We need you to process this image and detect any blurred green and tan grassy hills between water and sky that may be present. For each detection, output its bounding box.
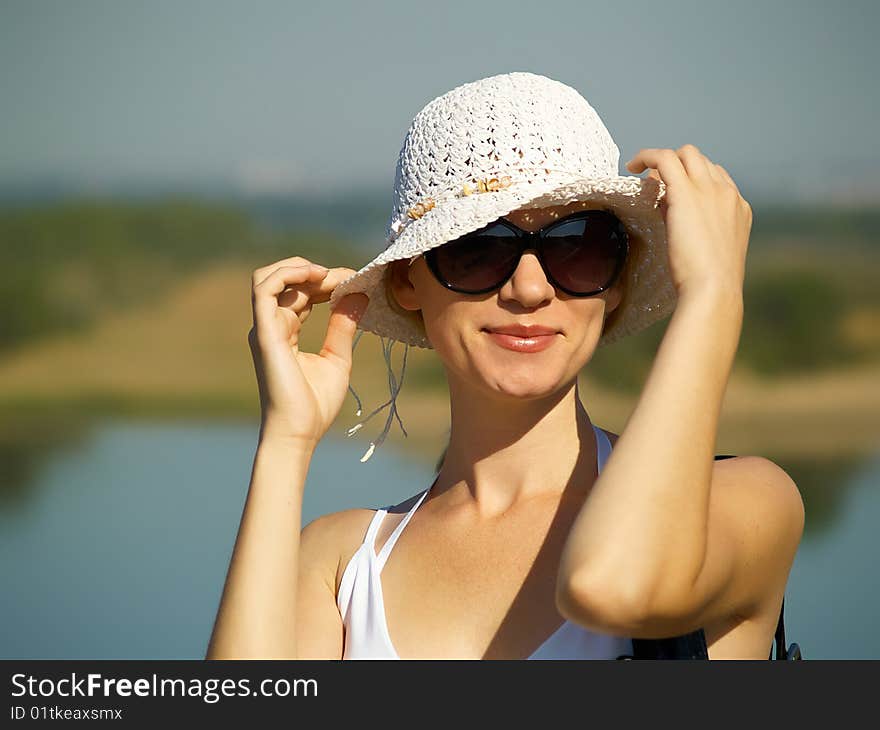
[0,193,880,460]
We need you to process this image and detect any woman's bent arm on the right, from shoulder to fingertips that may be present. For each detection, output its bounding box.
[556,145,804,638]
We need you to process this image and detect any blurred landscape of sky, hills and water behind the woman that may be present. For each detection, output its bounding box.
[0,0,880,658]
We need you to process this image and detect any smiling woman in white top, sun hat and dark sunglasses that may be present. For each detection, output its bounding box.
[208,73,804,659]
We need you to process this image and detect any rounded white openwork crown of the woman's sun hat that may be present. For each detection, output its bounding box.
[386,71,620,240]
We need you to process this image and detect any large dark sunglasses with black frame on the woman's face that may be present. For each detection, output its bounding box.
[410,210,629,297]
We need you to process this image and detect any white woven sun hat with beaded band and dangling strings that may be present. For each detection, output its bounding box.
[330,71,676,461]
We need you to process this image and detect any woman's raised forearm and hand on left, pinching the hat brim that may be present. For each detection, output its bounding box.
[206,257,367,659]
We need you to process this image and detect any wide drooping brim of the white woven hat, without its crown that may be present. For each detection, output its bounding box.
[330,176,676,349]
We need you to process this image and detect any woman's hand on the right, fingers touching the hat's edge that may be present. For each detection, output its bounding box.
[626,144,752,296]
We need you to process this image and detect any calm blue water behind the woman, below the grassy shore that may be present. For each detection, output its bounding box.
[0,421,880,659]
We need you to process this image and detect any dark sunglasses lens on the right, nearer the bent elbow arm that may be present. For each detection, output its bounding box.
[544,211,626,292]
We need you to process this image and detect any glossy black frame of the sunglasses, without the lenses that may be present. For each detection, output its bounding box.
[409,209,629,297]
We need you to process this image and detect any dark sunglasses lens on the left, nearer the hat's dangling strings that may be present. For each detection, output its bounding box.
[434,225,519,292]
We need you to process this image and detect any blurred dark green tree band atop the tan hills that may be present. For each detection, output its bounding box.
[0,199,880,390]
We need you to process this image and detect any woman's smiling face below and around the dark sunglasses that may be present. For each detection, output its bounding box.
[390,202,621,397]
